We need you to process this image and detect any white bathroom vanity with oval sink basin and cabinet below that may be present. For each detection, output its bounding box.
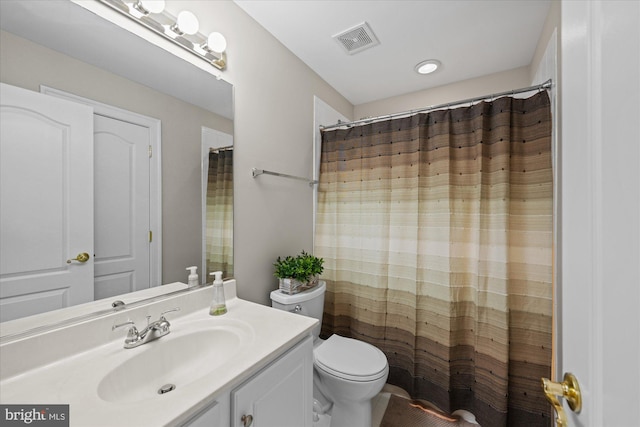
[0,280,317,427]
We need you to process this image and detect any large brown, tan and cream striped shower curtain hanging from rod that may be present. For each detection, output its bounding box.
[315,91,553,427]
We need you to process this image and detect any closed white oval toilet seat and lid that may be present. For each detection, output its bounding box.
[313,335,388,382]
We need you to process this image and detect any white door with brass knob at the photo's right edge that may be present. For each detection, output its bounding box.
[555,0,640,427]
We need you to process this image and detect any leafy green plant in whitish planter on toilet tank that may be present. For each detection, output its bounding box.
[273,251,324,295]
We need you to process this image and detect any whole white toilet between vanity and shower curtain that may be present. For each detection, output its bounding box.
[271,281,389,427]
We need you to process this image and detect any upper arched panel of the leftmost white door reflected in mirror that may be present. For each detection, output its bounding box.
[0,122,68,275]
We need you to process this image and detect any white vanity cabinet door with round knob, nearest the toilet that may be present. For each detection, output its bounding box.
[231,337,313,427]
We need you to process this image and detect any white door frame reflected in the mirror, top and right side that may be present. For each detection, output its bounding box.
[40,85,162,287]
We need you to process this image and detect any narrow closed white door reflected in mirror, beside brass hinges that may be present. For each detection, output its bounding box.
[94,114,151,299]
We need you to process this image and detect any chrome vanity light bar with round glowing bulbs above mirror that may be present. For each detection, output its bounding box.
[98,0,227,70]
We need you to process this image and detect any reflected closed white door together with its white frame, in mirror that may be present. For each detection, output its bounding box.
[40,86,162,299]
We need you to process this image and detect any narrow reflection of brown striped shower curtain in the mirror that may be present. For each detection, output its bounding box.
[205,148,233,280]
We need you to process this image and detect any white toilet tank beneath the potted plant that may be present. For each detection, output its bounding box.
[271,280,327,341]
